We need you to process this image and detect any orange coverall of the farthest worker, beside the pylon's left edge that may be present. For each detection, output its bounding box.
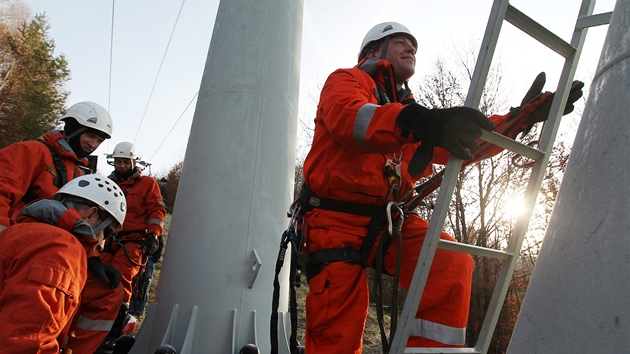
[101,168,166,303]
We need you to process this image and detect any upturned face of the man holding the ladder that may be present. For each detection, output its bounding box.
[368,36,416,82]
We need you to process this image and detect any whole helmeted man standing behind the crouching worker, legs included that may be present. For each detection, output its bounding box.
[0,101,129,353]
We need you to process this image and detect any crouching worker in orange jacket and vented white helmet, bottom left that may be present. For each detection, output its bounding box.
[0,175,127,353]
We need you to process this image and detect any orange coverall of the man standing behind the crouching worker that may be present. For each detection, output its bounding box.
[0,130,123,353]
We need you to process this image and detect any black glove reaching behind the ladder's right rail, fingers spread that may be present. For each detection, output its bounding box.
[516,72,584,127]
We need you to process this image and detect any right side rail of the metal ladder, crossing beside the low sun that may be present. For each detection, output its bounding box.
[475,0,595,353]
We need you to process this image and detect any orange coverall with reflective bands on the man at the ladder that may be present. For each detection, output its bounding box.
[304,60,507,353]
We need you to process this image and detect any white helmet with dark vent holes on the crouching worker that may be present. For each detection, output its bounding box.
[53,174,127,232]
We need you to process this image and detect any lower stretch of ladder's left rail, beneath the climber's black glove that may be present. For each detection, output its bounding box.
[389,156,463,354]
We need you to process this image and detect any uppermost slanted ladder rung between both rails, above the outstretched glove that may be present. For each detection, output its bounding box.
[505,5,575,58]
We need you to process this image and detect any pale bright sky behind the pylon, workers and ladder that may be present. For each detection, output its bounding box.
[24,0,615,175]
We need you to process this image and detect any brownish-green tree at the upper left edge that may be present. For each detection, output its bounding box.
[0,14,70,148]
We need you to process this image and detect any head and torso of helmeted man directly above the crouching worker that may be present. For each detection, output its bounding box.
[0,101,113,229]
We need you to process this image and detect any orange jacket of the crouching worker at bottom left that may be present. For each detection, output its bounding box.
[0,200,97,353]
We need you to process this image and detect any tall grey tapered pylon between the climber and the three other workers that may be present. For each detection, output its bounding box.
[131,0,304,354]
